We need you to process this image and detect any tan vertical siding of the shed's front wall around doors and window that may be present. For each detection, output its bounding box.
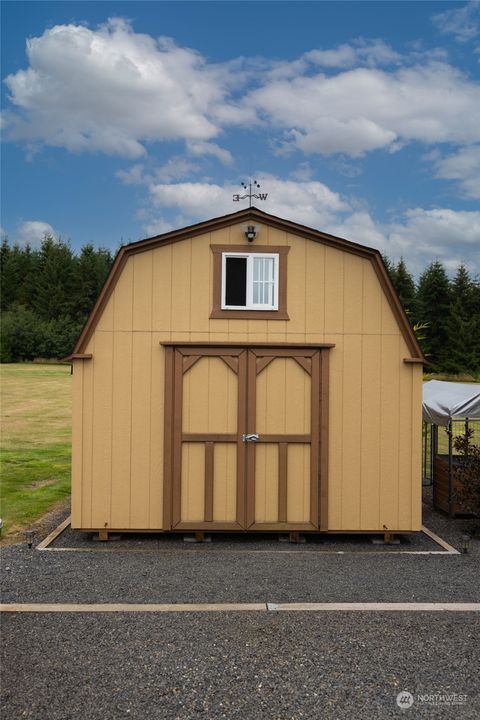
[72,225,421,530]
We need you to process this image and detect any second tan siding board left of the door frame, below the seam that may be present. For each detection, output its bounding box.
[130,332,151,528]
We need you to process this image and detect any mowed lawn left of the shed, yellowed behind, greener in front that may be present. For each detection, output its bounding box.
[0,363,71,535]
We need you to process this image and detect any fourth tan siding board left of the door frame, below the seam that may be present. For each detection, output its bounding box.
[92,332,113,528]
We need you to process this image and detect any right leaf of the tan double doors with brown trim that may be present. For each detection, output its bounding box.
[247,348,320,530]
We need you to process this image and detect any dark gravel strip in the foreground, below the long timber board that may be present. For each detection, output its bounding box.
[2,613,480,720]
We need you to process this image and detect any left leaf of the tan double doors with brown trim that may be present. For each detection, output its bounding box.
[171,348,247,530]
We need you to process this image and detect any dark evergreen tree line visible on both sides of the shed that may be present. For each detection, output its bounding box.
[0,236,480,373]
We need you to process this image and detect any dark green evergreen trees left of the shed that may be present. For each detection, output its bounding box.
[0,236,113,362]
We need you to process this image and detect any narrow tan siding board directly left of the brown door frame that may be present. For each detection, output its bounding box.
[149,338,165,529]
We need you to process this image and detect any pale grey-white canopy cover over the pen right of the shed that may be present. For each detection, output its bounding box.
[422,380,480,427]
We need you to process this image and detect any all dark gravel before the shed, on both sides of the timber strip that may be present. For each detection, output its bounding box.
[1,498,480,720]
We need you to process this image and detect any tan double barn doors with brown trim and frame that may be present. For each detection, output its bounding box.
[164,346,326,531]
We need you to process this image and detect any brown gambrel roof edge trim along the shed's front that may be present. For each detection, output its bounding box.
[65,207,425,361]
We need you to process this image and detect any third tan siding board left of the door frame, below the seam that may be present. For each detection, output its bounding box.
[112,332,133,529]
